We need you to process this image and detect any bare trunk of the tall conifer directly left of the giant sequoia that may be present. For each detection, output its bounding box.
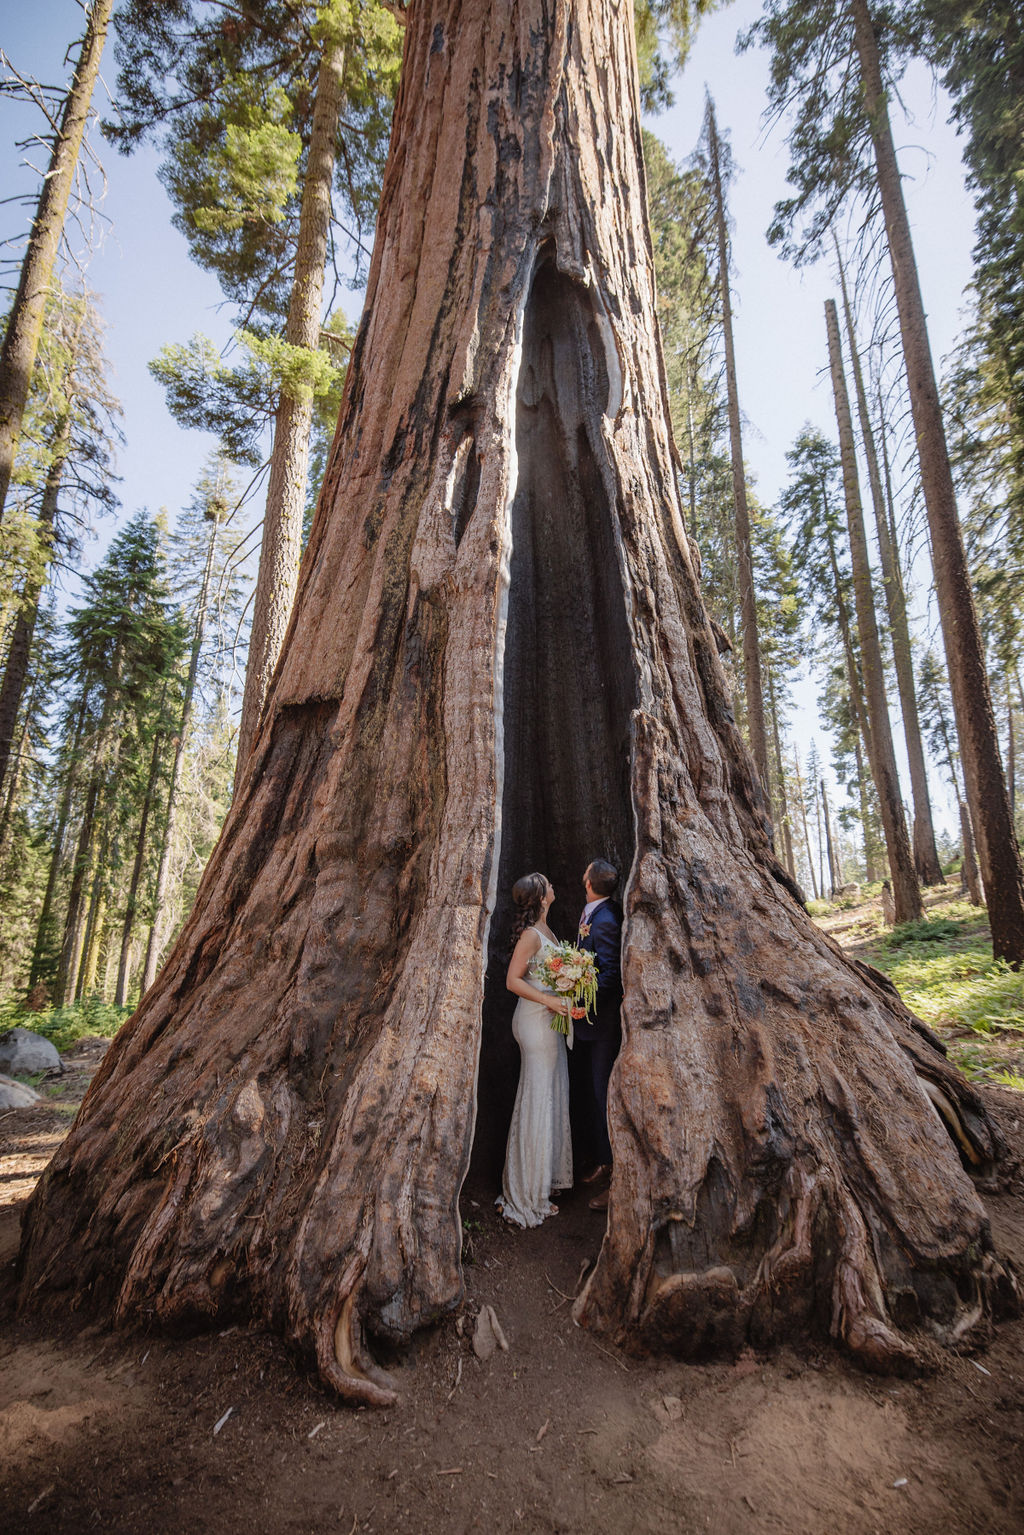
[234,37,345,779]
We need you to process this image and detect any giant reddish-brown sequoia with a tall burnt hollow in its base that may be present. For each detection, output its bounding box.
[21,0,1009,1401]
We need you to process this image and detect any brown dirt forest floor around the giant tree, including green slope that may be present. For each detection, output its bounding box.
[0,903,1024,1535]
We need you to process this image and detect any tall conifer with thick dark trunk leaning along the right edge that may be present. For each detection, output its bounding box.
[749,0,1024,964]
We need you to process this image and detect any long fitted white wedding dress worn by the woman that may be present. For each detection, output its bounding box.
[496,927,573,1226]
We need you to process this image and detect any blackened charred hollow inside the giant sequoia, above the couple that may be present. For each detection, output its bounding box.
[473,258,637,1180]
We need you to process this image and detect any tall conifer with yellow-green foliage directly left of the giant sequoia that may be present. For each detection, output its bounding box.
[111,0,401,772]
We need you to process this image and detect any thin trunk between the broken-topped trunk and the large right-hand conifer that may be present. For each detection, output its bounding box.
[835,241,944,884]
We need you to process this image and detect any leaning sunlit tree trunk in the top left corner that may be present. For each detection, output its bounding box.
[0,0,114,517]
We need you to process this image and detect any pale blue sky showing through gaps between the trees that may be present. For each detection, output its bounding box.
[0,0,973,841]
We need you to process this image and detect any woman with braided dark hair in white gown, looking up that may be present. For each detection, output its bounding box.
[496,873,573,1226]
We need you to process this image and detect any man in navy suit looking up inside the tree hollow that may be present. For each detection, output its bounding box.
[573,858,622,1210]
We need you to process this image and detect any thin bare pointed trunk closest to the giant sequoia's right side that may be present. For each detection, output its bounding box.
[708,100,769,794]
